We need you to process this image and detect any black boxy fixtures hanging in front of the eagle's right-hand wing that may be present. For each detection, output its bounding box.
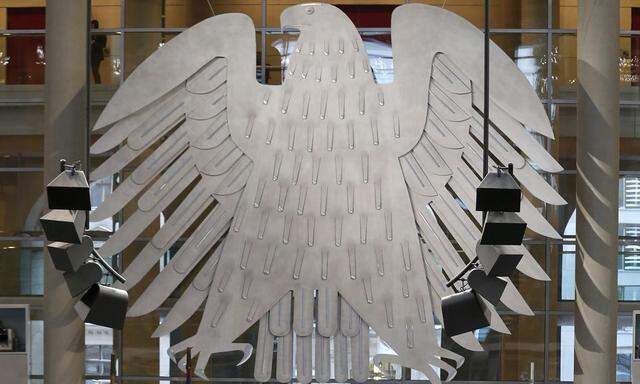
[442,164,527,336]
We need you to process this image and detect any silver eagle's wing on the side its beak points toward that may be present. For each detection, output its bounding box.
[91,14,270,340]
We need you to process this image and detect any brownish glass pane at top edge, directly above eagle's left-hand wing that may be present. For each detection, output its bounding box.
[125,0,262,28]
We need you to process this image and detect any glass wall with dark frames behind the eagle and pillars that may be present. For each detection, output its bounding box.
[0,0,640,384]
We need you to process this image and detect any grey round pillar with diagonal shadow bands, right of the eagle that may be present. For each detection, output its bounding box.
[574,0,620,384]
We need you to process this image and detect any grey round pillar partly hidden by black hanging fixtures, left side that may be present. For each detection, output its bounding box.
[44,0,88,384]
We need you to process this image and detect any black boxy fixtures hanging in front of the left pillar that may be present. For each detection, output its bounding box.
[40,160,129,329]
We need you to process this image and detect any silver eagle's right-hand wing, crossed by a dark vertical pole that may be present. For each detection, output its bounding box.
[389,4,566,349]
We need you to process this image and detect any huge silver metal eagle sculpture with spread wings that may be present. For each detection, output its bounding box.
[91,3,565,383]
